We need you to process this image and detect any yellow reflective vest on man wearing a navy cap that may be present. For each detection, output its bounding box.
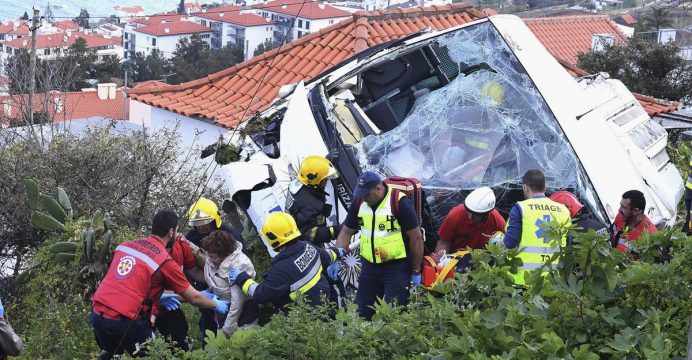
[358,186,406,263]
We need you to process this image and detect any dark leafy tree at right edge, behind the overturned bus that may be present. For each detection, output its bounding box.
[577,36,692,102]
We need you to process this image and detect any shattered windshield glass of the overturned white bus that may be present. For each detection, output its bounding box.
[346,22,594,236]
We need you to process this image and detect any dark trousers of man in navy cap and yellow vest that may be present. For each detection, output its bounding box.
[356,259,411,320]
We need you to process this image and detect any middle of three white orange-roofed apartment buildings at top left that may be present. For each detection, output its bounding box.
[193,10,274,60]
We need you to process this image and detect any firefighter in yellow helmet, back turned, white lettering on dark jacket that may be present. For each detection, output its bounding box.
[229,212,344,312]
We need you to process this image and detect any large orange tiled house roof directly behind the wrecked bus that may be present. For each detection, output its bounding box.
[128,4,483,127]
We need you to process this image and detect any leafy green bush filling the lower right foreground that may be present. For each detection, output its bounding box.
[137,226,692,360]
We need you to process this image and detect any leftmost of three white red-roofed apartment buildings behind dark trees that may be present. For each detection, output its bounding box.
[123,14,212,59]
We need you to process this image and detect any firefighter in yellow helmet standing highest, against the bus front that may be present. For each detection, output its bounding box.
[286,156,338,244]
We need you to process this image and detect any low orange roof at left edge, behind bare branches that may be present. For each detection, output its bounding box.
[0,89,129,121]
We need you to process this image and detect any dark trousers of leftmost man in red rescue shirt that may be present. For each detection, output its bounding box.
[89,311,154,360]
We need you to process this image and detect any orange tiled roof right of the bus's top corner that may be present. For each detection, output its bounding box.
[524,15,627,65]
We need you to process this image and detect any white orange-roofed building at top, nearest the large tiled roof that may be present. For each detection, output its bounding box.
[253,0,351,42]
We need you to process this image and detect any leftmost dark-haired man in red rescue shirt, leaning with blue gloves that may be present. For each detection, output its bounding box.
[89,210,228,359]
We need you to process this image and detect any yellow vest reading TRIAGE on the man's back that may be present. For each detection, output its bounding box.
[507,197,572,285]
